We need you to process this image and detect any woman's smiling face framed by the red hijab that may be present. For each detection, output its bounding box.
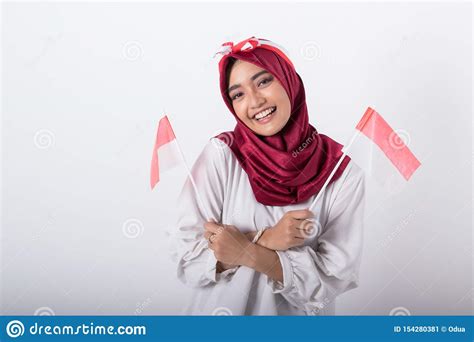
[227,60,291,136]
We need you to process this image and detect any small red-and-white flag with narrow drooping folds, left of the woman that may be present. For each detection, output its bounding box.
[150,115,183,190]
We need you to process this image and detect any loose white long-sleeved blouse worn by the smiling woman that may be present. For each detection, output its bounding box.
[172,138,365,315]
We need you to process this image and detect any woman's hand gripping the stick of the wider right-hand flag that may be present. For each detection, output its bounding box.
[257,209,316,251]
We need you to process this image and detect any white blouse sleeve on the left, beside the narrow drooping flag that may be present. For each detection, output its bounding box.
[173,139,237,287]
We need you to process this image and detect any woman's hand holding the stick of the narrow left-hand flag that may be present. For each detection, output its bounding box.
[204,222,252,265]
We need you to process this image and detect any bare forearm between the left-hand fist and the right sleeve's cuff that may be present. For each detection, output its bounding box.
[242,243,283,282]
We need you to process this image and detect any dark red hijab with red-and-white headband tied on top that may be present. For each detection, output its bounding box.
[217,37,350,206]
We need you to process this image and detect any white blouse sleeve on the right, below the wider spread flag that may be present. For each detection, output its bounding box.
[268,163,365,315]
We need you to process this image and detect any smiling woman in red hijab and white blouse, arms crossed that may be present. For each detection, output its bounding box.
[171,37,364,315]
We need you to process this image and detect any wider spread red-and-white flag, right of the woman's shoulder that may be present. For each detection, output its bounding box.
[343,107,421,186]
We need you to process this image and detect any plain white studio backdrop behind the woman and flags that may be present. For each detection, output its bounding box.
[1,2,473,315]
